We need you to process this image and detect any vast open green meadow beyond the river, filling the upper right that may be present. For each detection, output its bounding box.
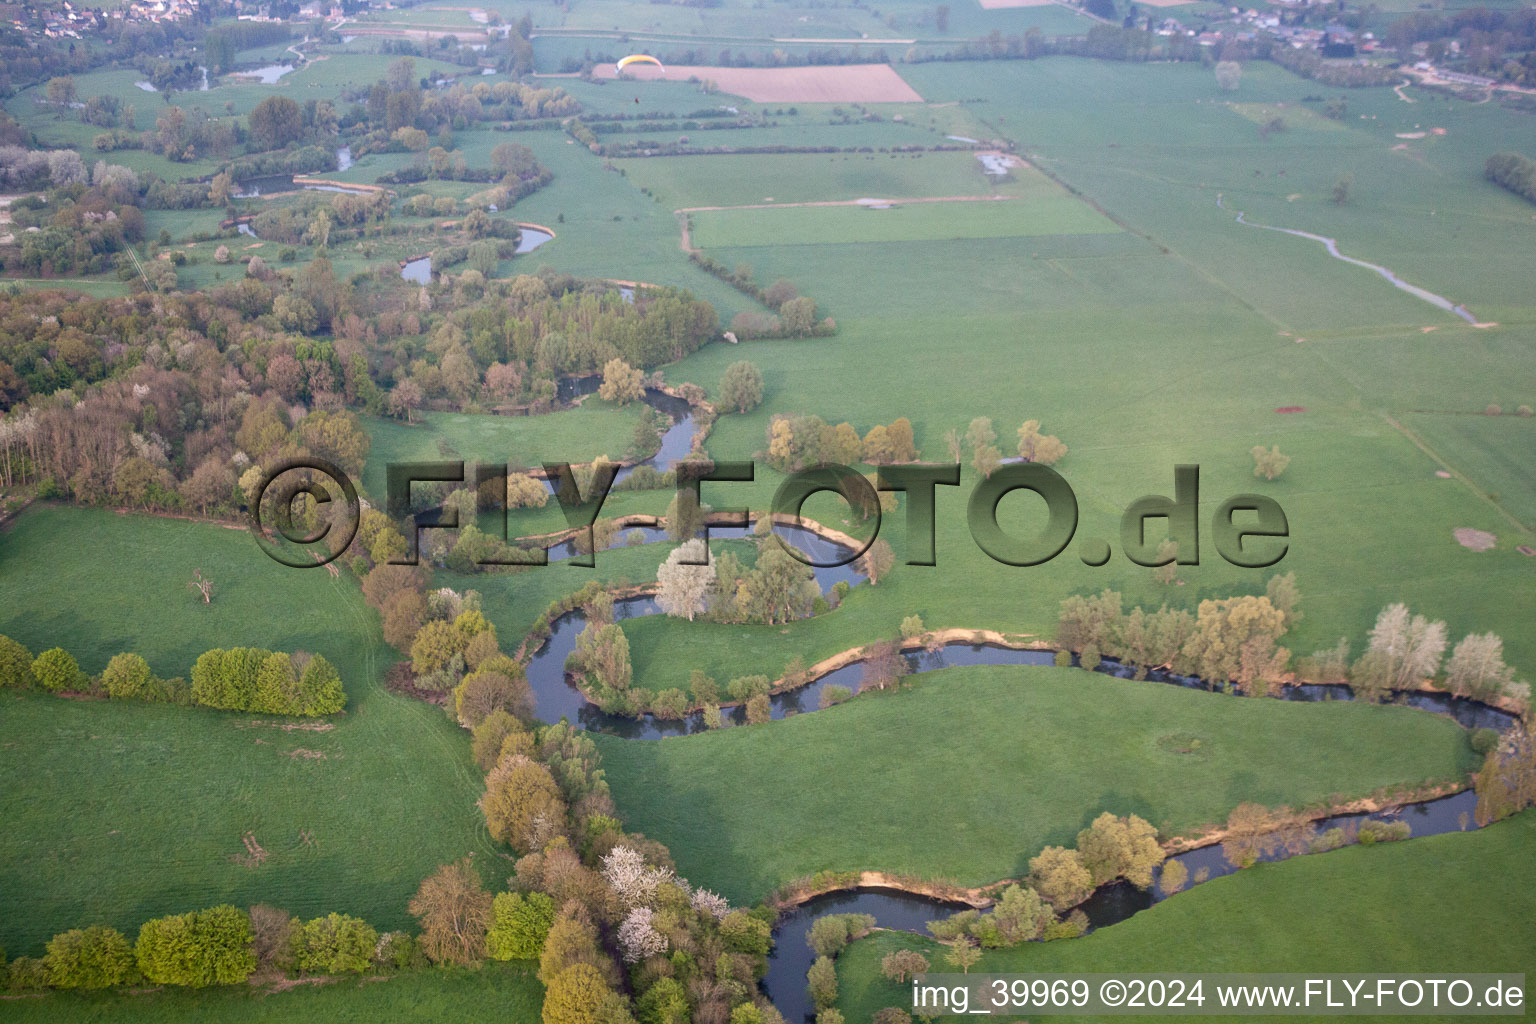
[577,60,1536,685]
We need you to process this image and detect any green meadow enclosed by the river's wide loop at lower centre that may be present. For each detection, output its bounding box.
[598,668,1475,902]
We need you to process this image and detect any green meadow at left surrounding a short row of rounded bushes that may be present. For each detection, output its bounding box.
[0,508,493,956]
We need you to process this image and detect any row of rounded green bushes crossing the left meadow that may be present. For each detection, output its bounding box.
[0,636,347,715]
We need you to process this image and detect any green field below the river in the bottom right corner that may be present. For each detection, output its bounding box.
[837,812,1536,1021]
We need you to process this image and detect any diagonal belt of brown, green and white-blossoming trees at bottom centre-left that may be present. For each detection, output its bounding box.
[337,517,782,1024]
